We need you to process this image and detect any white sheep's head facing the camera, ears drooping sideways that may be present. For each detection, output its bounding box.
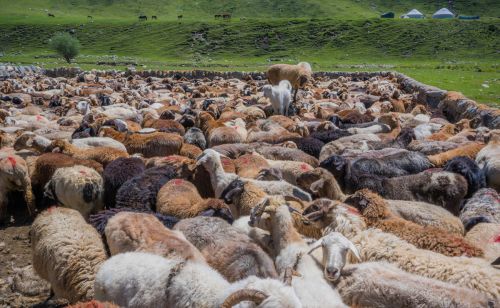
[309,232,361,282]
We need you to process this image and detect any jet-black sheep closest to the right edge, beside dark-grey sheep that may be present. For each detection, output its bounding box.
[444,156,486,198]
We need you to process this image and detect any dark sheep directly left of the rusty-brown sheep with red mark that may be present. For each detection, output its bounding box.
[116,166,179,211]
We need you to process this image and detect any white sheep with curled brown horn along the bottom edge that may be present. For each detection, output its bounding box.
[95,252,302,308]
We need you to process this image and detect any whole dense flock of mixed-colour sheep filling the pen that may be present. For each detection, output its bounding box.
[0,63,500,307]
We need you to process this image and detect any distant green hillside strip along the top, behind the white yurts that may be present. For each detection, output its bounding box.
[0,0,500,22]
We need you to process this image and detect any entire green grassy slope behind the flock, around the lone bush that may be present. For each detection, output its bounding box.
[0,0,500,103]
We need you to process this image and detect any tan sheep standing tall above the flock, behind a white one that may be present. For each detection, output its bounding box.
[267,62,312,103]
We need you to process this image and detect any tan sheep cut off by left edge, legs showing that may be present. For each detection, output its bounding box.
[0,151,35,221]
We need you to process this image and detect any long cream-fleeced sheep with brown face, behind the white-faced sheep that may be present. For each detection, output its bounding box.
[303,203,500,301]
